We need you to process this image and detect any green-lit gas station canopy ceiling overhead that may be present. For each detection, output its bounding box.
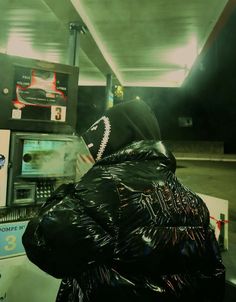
[0,0,232,87]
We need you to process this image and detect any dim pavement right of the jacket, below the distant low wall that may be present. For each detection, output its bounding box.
[175,158,236,286]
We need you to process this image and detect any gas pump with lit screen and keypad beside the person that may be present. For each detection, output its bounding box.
[0,54,93,302]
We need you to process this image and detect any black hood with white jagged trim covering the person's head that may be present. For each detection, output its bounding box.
[82,100,161,161]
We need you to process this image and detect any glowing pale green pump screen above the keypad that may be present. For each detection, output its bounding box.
[21,139,74,177]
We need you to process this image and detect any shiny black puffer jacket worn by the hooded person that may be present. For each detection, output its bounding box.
[23,141,225,302]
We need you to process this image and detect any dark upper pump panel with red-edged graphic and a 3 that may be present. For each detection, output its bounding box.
[12,66,69,122]
